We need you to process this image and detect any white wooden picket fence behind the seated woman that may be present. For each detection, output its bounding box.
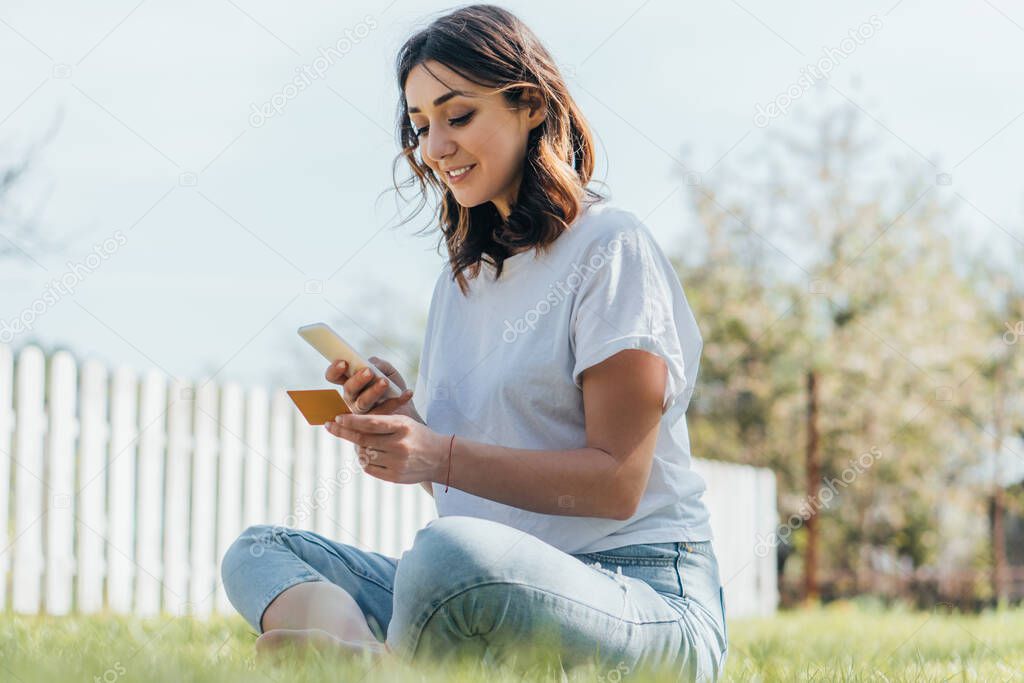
[0,345,777,616]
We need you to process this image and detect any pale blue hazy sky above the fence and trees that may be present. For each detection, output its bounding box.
[0,0,1024,395]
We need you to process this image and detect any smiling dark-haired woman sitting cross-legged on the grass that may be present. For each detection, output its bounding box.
[222,5,727,680]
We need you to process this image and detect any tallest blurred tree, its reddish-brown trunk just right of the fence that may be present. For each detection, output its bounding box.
[677,100,987,598]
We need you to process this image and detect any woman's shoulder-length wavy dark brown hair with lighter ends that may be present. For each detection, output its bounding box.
[393,4,605,295]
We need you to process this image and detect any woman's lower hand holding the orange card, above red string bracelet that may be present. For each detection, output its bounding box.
[324,414,449,483]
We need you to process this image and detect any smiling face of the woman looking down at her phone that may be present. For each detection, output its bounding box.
[406,59,545,217]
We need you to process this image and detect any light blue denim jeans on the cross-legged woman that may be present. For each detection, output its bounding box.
[221,516,728,681]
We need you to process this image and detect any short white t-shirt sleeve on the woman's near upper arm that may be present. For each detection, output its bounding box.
[570,214,702,419]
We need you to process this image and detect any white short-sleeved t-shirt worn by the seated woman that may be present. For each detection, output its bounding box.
[414,202,712,553]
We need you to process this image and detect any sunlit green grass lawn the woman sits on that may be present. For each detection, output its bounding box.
[0,603,1024,683]
